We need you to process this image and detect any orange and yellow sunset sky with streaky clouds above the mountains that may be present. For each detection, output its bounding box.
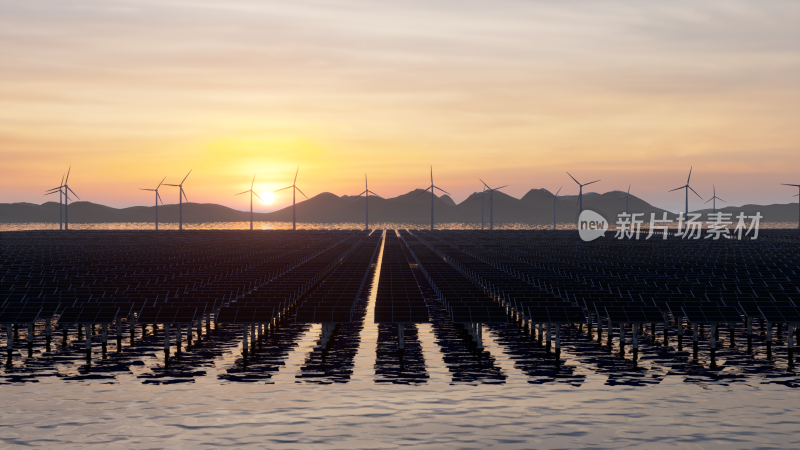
[0,0,800,211]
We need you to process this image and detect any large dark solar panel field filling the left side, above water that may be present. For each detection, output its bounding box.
[0,231,364,354]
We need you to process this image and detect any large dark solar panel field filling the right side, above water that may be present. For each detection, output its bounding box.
[415,230,800,354]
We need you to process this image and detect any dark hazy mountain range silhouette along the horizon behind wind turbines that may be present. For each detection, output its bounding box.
[0,189,798,224]
